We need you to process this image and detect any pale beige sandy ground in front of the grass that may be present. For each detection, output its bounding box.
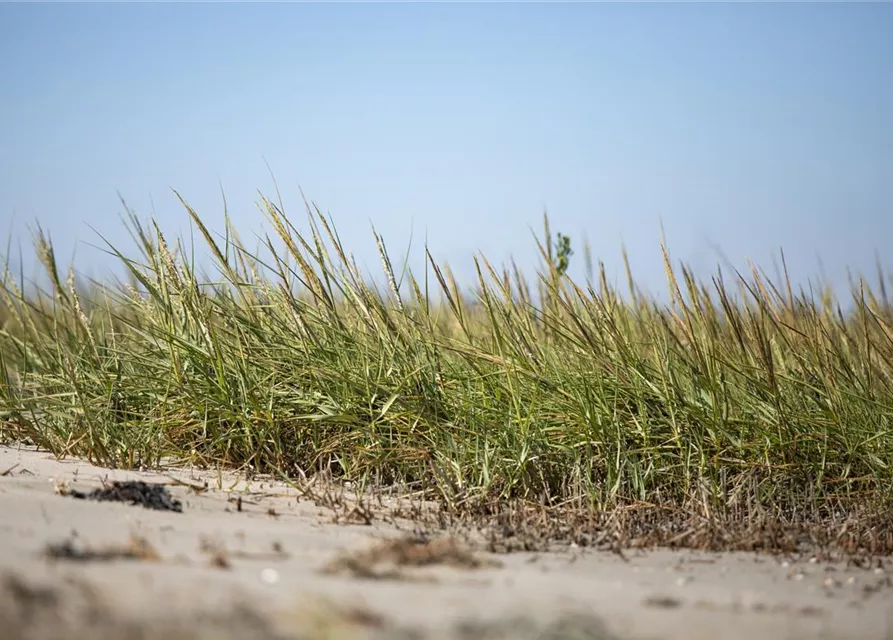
[0,447,893,640]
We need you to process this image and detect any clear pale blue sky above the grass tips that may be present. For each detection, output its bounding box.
[0,2,893,298]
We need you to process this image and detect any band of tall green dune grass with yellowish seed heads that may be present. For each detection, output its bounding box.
[0,192,893,532]
